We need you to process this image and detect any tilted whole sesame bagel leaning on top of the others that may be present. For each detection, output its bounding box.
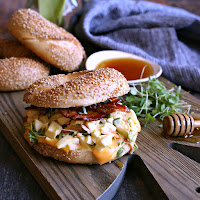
[8,9,85,72]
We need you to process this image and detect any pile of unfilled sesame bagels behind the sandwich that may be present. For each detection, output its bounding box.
[0,9,85,91]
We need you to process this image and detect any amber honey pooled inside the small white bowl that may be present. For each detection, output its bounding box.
[97,58,154,81]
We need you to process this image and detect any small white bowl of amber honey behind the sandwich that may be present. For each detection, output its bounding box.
[85,50,162,84]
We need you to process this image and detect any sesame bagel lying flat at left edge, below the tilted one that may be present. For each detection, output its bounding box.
[0,57,49,91]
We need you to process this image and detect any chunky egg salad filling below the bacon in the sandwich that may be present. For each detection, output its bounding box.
[24,105,141,164]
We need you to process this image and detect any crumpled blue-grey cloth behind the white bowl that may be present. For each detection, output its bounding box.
[71,0,200,92]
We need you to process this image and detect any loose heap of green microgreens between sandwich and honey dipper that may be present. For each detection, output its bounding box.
[121,77,191,126]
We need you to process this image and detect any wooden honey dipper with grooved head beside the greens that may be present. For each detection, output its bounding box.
[163,114,200,136]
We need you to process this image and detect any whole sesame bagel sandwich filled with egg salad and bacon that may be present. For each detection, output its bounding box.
[23,68,141,165]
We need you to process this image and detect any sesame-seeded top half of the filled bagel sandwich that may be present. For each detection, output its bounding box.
[24,68,129,108]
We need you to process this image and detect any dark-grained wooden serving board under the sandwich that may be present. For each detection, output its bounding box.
[0,78,200,200]
